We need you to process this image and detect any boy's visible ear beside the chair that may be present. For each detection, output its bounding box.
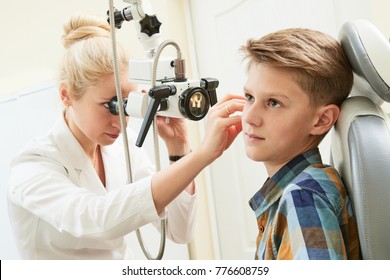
[311,104,340,135]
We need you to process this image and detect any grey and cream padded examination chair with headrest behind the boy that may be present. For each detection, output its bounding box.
[330,20,390,260]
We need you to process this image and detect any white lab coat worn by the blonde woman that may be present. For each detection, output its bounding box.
[8,115,196,259]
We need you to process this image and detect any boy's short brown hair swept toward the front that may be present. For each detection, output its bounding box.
[241,28,353,106]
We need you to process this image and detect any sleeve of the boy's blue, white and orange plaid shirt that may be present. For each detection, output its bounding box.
[273,189,347,260]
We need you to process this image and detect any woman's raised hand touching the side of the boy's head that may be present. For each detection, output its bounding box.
[199,94,245,161]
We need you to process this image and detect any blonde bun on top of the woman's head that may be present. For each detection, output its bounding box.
[62,14,110,48]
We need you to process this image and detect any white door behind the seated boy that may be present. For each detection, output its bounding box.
[189,0,370,259]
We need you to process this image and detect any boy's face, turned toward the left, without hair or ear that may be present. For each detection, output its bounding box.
[242,63,317,176]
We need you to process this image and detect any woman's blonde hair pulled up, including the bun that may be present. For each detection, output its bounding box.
[60,14,128,99]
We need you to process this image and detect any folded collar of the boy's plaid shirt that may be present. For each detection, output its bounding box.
[249,148,322,217]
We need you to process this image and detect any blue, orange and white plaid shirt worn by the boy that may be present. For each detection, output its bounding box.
[249,148,360,260]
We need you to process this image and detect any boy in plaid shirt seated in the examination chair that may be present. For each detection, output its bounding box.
[241,28,360,260]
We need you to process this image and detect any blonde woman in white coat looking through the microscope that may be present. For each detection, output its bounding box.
[8,12,243,259]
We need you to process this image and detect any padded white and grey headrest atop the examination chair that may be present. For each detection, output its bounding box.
[339,20,390,102]
